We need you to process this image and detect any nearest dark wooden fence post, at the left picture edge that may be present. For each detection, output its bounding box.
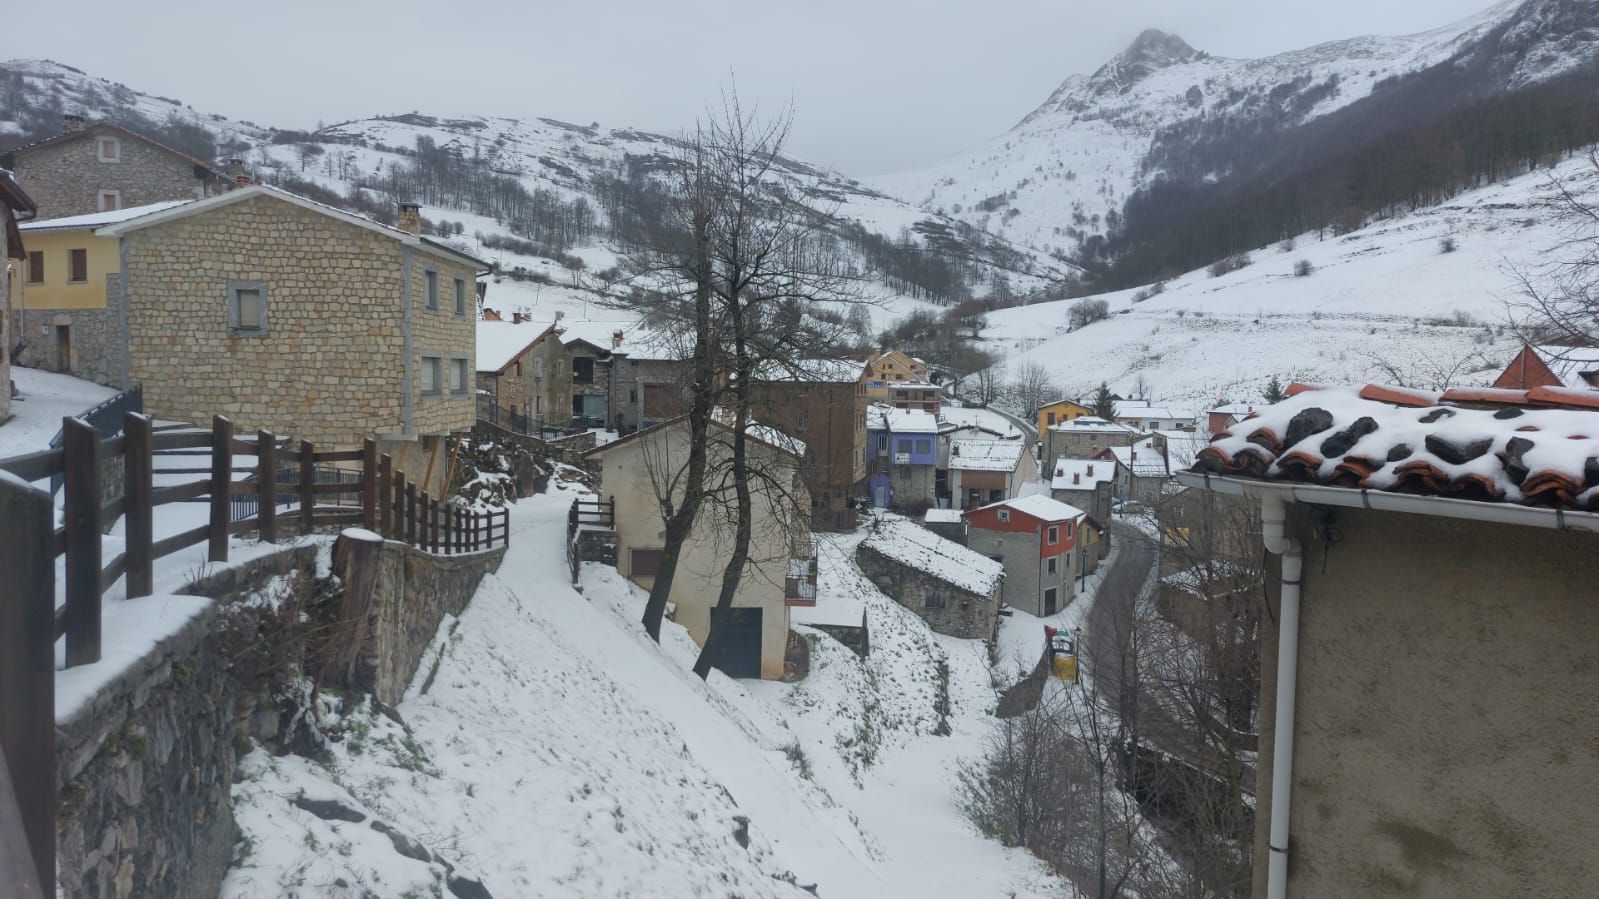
[0,478,55,896]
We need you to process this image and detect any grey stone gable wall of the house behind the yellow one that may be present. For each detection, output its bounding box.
[16,128,212,219]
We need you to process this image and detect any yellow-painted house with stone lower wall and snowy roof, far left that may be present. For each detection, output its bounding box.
[11,200,184,380]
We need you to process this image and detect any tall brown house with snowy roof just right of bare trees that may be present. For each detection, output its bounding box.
[750,353,867,531]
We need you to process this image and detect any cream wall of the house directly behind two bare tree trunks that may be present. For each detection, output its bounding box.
[590,422,807,678]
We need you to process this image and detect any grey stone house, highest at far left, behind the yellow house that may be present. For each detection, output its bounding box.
[0,115,235,219]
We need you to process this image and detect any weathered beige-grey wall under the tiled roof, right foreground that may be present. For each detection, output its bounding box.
[1255,505,1599,897]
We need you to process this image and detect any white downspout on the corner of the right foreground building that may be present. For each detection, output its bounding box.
[1260,493,1305,899]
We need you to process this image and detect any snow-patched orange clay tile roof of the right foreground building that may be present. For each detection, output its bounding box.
[1194,384,1599,510]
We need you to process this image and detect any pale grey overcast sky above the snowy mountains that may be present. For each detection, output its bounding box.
[12,0,1490,176]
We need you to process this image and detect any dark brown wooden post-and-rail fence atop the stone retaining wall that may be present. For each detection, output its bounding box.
[0,413,510,885]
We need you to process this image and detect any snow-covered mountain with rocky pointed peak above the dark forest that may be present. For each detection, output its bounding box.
[870,0,1599,253]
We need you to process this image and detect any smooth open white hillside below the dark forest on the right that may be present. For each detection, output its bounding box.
[983,152,1588,411]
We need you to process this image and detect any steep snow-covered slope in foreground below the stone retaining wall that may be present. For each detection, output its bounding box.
[222,481,1063,897]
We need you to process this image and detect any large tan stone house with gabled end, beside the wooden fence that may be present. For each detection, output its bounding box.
[98,186,488,493]
